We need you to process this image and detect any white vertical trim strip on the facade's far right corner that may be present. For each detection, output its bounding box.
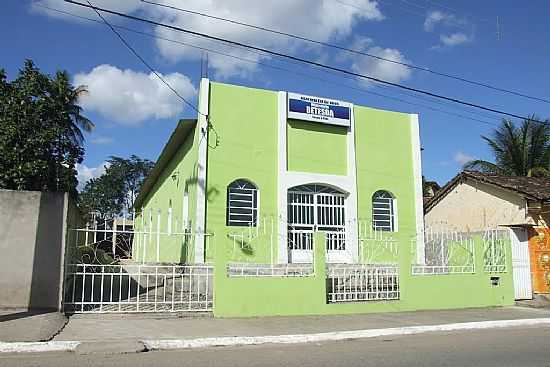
[410,114,426,265]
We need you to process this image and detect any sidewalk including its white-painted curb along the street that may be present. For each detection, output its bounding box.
[0,307,550,354]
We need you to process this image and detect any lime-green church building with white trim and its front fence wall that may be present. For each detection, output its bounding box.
[110,79,514,317]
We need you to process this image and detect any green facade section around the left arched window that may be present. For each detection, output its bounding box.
[206,83,278,263]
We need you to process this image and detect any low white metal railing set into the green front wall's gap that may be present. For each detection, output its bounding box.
[327,265,400,303]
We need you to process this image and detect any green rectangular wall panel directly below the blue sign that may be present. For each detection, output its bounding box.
[287,120,348,175]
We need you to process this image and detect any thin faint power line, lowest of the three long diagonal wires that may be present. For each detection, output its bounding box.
[36,4,498,126]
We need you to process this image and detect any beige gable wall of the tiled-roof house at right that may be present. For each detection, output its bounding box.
[425,181,533,231]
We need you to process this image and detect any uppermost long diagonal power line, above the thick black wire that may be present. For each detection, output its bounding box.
[141,0,550,103]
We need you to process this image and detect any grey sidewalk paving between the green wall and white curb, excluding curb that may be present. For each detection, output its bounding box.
[54,307,550,341]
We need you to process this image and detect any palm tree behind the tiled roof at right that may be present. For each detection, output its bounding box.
[464,115,550,177]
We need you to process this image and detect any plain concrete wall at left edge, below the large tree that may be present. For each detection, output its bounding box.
[0,190,73,309]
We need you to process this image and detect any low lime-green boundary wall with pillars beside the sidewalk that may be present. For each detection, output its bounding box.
[214,233,514,317]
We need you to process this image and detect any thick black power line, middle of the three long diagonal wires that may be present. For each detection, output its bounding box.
[64,0,547,125]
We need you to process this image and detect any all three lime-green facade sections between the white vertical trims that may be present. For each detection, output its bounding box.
[206,83,416,263]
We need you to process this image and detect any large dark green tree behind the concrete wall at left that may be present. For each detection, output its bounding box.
[0,60,94,194]
